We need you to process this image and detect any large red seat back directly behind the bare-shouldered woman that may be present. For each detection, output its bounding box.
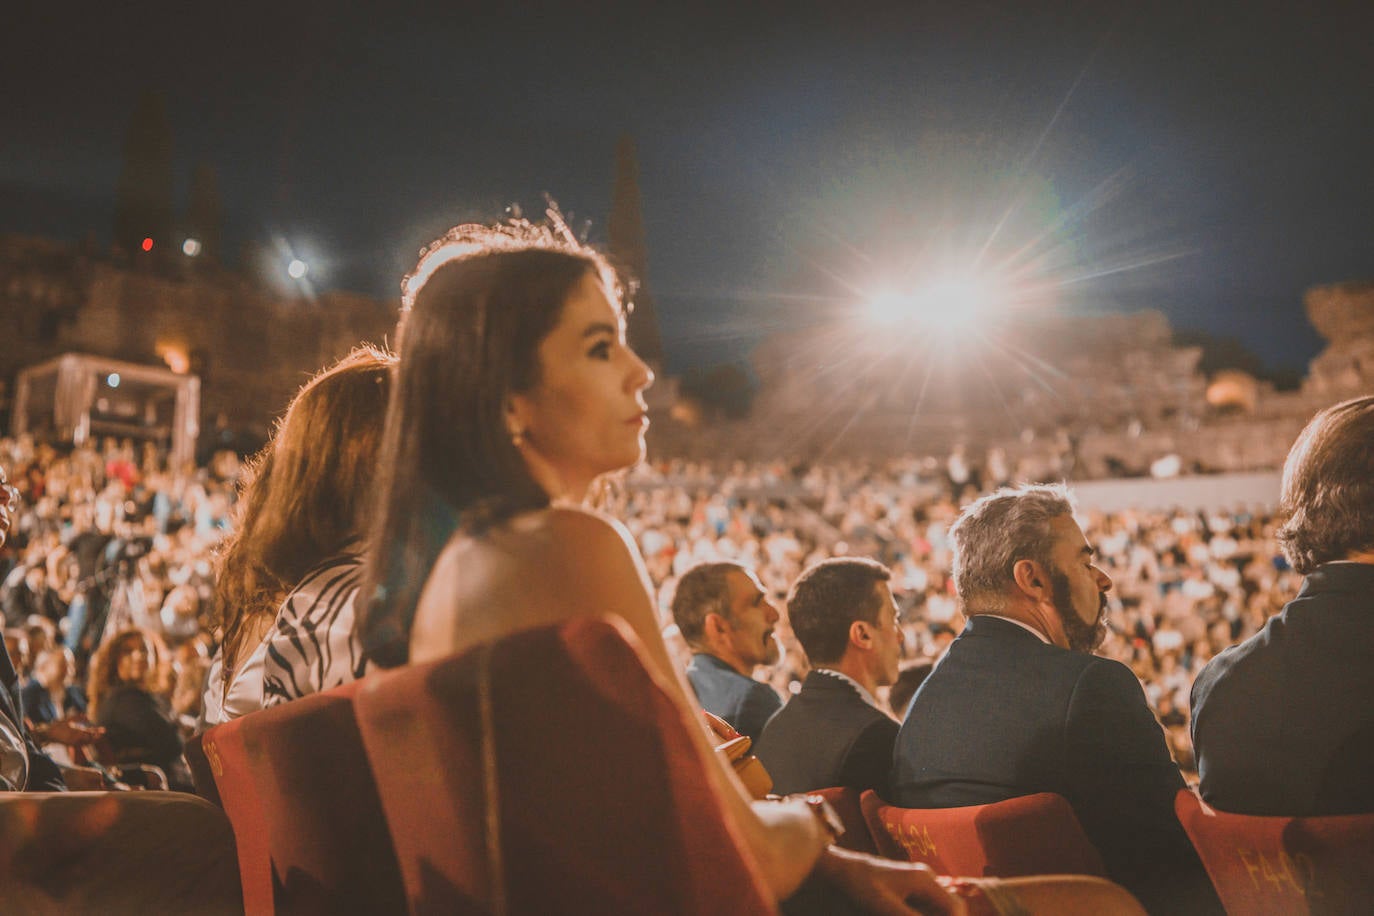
[357,619,775,916]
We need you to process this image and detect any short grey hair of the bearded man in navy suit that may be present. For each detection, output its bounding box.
[949,483,1073,614]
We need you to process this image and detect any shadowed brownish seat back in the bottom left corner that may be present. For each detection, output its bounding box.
[0,792,243,916]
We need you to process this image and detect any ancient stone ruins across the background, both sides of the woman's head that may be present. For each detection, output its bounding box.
[0,236,1374,475]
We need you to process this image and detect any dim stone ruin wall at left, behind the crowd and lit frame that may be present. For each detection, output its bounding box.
[0,236,397,441]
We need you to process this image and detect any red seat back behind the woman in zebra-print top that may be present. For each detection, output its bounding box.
[203,683,405,916]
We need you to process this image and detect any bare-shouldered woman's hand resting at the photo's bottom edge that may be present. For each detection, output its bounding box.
[816,846,967,916]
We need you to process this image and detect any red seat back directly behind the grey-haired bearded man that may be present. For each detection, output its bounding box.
[861,791,1106,878]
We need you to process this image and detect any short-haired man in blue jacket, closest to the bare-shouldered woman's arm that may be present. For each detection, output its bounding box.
[672,563,782,740]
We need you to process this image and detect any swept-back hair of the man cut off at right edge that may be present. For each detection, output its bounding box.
[1278,397,1374,575]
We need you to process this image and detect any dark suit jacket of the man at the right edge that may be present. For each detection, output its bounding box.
[1193,563,1374,816]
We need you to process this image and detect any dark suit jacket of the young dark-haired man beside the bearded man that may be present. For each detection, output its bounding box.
[754,672,897,795]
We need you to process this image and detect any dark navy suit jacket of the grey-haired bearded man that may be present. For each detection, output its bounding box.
[889,615,1220,913]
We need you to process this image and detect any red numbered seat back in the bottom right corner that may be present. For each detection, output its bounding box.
[1173,788,1374,916]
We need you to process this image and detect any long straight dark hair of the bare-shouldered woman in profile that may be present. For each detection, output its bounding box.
[359,221,628,666]
